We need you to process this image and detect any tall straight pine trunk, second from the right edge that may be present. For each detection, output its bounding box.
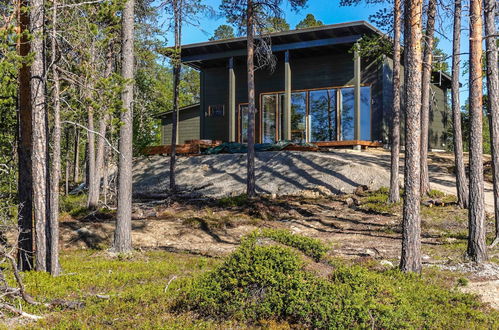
[468,0,488,262]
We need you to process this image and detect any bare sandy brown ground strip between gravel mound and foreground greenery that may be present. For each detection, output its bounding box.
[54,189,499,314]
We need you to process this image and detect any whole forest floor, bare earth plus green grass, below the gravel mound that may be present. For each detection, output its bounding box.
[0,152,499,329]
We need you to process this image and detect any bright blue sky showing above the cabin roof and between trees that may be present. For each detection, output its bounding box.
[162,0,468,102]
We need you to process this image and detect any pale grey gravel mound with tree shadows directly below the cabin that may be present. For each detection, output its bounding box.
[133,151,389,197]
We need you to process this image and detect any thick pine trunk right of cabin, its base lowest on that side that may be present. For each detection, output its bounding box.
[400,0,422,273]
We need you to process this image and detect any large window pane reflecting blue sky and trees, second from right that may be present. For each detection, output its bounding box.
[309,89,336,142]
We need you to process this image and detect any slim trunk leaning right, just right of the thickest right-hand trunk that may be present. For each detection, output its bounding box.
[420,0,437,196]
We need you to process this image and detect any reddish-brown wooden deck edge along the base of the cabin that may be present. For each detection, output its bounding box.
[142,140,383,156]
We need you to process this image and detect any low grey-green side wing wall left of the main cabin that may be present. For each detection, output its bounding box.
[161,107,200,145]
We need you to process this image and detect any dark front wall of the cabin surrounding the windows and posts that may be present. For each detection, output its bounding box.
[201,51,383,141]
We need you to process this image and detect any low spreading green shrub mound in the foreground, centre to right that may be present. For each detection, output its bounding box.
[174,233,499,329]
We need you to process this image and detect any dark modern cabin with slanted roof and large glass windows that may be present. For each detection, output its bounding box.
[160,21,451,150]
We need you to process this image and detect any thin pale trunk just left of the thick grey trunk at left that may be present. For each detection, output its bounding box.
[85,42,99,210]
